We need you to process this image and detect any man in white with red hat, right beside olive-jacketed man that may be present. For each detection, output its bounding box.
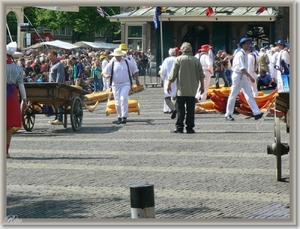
[195,44,213,102]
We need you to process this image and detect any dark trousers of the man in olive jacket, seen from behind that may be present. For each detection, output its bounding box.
[175,96,195,131]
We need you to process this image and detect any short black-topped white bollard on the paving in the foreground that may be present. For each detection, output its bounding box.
[130,184,155,219]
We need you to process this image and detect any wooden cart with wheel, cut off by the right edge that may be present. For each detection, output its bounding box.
[267,92,290,181]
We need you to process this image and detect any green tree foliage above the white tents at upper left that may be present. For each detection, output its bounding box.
[24,6,120,42]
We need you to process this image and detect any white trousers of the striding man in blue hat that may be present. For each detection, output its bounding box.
[225,72,260,117]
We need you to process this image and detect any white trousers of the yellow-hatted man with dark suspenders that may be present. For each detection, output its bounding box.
[112,82,130,118]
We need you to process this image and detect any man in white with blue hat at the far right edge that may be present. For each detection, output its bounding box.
[276,40,290,92]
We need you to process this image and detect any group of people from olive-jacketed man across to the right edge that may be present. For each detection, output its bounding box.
[160,37,290,133]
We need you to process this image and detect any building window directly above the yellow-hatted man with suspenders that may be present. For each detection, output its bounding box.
[127,24,143,50]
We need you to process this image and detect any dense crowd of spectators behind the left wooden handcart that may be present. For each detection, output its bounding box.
[16,46,153,91]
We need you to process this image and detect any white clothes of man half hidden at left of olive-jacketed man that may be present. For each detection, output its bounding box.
[160,56,177,97]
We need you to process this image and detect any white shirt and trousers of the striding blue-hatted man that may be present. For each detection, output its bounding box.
[225,49,260,117]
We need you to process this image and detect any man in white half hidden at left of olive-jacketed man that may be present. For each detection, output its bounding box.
[160,48,177,119]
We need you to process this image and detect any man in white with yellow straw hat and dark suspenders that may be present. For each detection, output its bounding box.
[102,48,140,124]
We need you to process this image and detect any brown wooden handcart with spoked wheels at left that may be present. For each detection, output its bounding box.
[22,83,89,131]
